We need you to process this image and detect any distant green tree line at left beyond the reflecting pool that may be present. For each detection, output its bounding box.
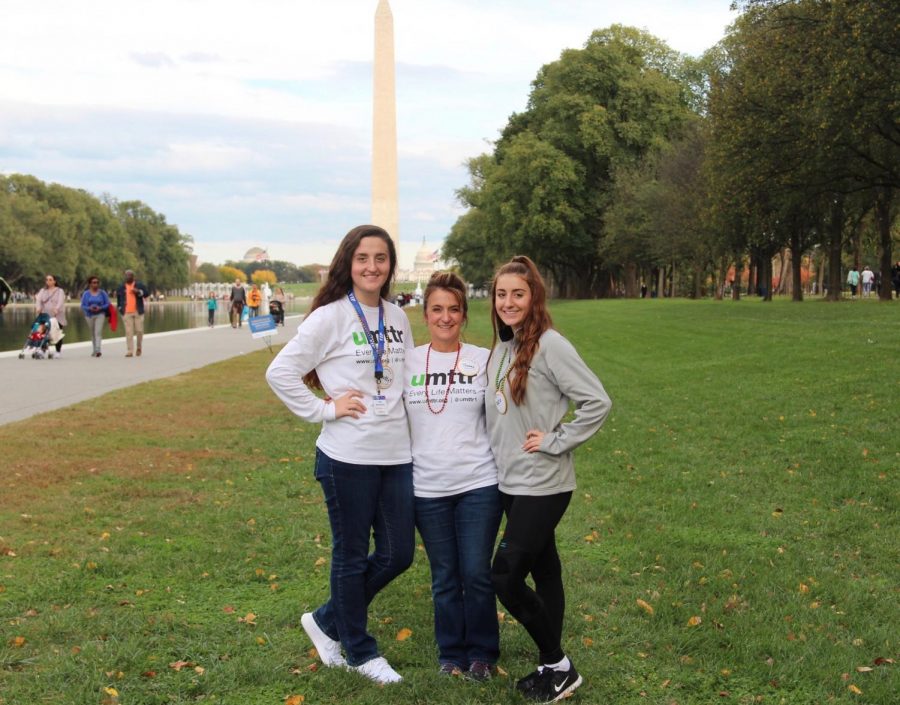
[0,174,191,293]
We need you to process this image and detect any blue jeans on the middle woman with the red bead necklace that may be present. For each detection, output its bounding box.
[416,485,503,669]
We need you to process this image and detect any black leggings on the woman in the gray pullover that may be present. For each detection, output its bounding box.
[491,492,572,663]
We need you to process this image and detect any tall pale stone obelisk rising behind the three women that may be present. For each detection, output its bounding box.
[372,0,400,250]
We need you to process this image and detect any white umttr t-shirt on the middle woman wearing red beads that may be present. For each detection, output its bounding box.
[404,344,497,497]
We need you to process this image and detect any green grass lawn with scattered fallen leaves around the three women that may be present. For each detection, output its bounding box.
[0,300,900,705]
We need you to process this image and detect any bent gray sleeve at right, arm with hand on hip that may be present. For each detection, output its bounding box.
[526,336,612,455]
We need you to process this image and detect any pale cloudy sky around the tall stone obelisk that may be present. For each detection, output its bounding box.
[0,0,736,268]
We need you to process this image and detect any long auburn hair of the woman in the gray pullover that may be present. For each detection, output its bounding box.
[491,255,553,405]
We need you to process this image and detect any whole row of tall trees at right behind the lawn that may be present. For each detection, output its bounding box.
[443,0,900,299]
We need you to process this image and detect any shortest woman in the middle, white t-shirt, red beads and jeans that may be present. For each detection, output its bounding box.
[404,272,502,680]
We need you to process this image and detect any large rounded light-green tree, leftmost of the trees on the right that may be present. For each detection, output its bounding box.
[445,25,690,296]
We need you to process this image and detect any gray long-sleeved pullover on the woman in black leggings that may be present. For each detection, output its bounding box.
[484,329,612,495]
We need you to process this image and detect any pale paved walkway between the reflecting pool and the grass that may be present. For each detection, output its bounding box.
[0,316,302,425]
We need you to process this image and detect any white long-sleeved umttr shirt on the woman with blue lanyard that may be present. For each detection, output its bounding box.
[266,297,413,465]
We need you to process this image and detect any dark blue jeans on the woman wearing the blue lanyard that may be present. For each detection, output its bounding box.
[313,448,415,666]
